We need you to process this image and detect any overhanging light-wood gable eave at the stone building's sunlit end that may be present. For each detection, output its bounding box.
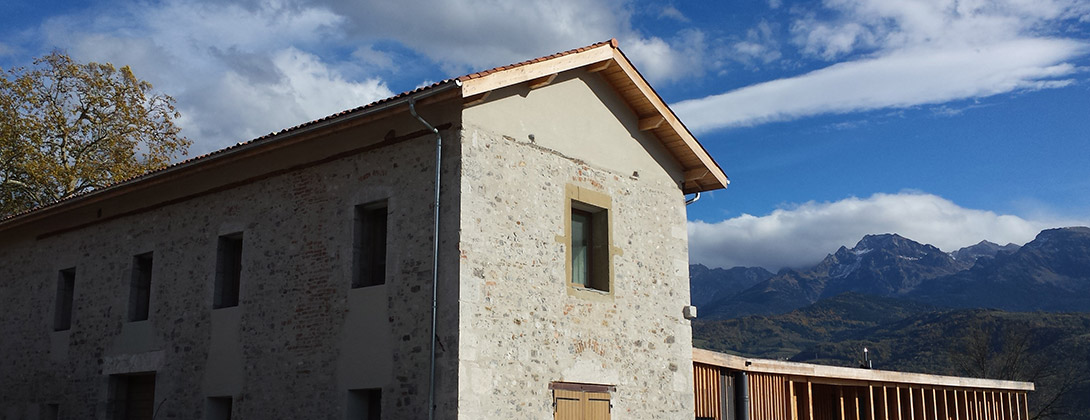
[459,39,730,193]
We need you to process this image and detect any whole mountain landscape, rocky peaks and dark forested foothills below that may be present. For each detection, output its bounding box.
[690,227,1090,420]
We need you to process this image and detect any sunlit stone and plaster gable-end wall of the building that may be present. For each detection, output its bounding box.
[458,73,693,419]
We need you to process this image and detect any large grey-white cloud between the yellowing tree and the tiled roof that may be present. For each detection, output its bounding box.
[41,0,392,155]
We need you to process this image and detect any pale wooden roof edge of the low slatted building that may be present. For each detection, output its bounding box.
[692,348,1033,391]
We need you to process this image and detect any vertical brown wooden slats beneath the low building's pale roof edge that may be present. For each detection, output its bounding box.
[693,361,1032,420]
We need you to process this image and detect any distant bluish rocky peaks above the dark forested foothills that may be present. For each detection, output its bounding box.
[690,227,1090,319]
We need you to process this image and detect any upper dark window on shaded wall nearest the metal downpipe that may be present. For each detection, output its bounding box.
[352,201,388,288]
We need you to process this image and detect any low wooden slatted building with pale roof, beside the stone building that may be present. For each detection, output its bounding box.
[693,349,1033,420]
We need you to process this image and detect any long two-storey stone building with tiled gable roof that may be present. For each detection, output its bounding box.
[0,41,727,419]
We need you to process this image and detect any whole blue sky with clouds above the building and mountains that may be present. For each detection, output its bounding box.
[0,0,1090,269]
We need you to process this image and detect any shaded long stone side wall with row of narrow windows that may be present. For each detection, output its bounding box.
[0,103,461,419]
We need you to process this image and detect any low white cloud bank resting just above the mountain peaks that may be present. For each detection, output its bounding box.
[689,192,1087,271]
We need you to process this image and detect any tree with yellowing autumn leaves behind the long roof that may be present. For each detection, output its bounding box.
[0,52,190,217]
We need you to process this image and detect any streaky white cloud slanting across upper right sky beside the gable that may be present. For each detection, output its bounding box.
[675,0,1090,132]
